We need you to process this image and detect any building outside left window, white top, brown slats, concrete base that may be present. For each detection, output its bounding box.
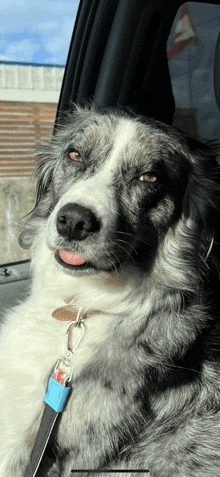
[0,61,64,263]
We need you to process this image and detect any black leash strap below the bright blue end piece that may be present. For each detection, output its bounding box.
[24,404,59,477]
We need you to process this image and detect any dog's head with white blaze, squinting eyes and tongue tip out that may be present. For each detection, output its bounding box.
[21,108,219,284]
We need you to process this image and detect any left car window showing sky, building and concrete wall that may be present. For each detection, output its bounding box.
[0,0,79,264]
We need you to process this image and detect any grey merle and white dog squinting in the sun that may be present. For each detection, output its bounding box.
[0,106,220,477]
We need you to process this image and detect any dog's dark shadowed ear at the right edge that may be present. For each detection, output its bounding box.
[183,148,220,235]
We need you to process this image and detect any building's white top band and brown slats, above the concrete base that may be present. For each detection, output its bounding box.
[0,61,64,178]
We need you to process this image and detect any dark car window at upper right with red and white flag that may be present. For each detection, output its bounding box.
[167,2,220,144]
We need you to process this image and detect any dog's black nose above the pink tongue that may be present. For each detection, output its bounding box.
[57,203,100,241]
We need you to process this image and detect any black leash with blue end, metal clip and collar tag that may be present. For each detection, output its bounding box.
[24,306,101,477]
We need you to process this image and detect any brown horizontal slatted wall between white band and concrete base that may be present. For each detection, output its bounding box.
[0,101,57,177]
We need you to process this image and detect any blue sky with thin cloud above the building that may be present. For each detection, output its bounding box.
[0,0,79,65]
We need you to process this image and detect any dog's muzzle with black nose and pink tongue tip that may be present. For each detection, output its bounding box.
[54,202,130,276]
